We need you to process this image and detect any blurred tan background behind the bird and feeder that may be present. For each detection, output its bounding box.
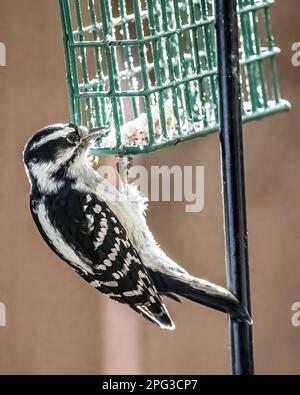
[0,0,300,374]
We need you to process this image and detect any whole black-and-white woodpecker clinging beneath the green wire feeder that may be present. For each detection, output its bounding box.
[24,124,251,329]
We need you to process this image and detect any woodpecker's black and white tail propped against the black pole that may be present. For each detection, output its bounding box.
[151,271,252,325]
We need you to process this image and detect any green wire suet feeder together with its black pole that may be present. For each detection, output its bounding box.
[59,0,290,374]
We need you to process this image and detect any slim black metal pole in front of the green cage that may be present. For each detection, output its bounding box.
[215,0,254,375]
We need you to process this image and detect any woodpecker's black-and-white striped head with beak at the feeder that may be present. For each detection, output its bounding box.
[24,124,99,192]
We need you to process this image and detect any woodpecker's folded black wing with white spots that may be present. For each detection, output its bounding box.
[32,188,174,329]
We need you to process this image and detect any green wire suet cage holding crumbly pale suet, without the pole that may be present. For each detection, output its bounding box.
[60,0,289,155]
